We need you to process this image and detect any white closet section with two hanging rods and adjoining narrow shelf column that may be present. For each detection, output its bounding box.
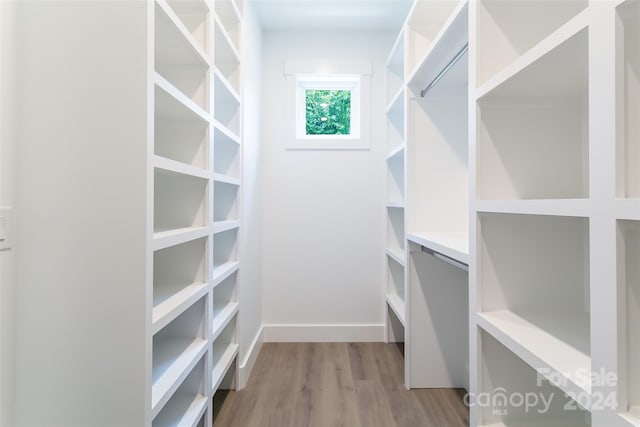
[387,1,469,389]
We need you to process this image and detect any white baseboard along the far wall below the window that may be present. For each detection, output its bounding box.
[262,324,385,342]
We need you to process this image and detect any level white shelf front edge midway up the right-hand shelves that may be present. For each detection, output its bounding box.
[476,199,593,217]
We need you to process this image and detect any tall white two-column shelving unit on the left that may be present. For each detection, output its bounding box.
[154,0,242,426]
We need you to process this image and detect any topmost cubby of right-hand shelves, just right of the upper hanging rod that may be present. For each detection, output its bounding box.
[475,0,588,85]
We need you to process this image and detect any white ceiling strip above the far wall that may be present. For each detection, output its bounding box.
[248,0,412,31]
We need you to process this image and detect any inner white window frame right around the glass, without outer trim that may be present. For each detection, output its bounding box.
[296,74,362,139]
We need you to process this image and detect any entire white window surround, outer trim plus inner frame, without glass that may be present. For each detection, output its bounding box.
[284,59,373,150]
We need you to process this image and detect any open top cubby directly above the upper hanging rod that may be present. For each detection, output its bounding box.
[405,0,460,77]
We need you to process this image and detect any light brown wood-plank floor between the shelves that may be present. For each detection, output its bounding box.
[213,343,469,427]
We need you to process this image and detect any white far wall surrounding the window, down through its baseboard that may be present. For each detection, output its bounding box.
[262,31,394,341]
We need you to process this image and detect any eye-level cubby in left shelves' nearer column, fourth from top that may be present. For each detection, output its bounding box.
[153,169,208,234]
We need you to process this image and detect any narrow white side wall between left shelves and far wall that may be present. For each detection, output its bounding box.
[239,2,262,387]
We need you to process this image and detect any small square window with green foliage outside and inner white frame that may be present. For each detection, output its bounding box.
[296,75,360,139]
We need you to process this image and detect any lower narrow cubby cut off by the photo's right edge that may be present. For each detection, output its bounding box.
[617,221,640,425]
